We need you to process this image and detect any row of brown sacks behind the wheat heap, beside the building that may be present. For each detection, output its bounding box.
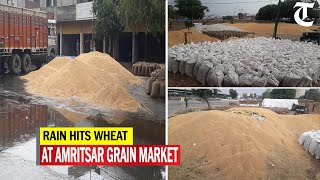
[132,62,164,76]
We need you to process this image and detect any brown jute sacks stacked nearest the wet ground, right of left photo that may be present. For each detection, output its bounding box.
[147,67,166,99]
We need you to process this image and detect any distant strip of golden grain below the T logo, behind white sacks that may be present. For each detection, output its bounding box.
[224,23,317,36]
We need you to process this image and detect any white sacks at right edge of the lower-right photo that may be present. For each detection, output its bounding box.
[299,131,320,159]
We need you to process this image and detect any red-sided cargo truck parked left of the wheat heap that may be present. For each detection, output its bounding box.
[0,4,57,75]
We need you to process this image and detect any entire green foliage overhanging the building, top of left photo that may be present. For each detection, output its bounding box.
[93,0,165,37]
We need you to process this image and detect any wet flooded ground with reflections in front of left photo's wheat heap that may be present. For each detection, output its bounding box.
[0,76,165,179]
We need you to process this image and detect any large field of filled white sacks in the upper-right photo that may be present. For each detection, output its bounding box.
[168,37,320,87]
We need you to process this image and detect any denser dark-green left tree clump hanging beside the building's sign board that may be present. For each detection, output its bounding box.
[92,0,124,38]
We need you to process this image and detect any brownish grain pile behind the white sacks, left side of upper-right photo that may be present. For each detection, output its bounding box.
[168,29,219,47]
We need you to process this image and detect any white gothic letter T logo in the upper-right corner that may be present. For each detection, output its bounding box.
[293,2,314,27]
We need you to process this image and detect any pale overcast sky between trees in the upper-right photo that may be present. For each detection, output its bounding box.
[169,0,318,16]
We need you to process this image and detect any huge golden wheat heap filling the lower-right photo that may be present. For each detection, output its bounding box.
[168,107,320,179]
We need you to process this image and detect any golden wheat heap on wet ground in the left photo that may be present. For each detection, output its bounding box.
[22,52,140,111]
